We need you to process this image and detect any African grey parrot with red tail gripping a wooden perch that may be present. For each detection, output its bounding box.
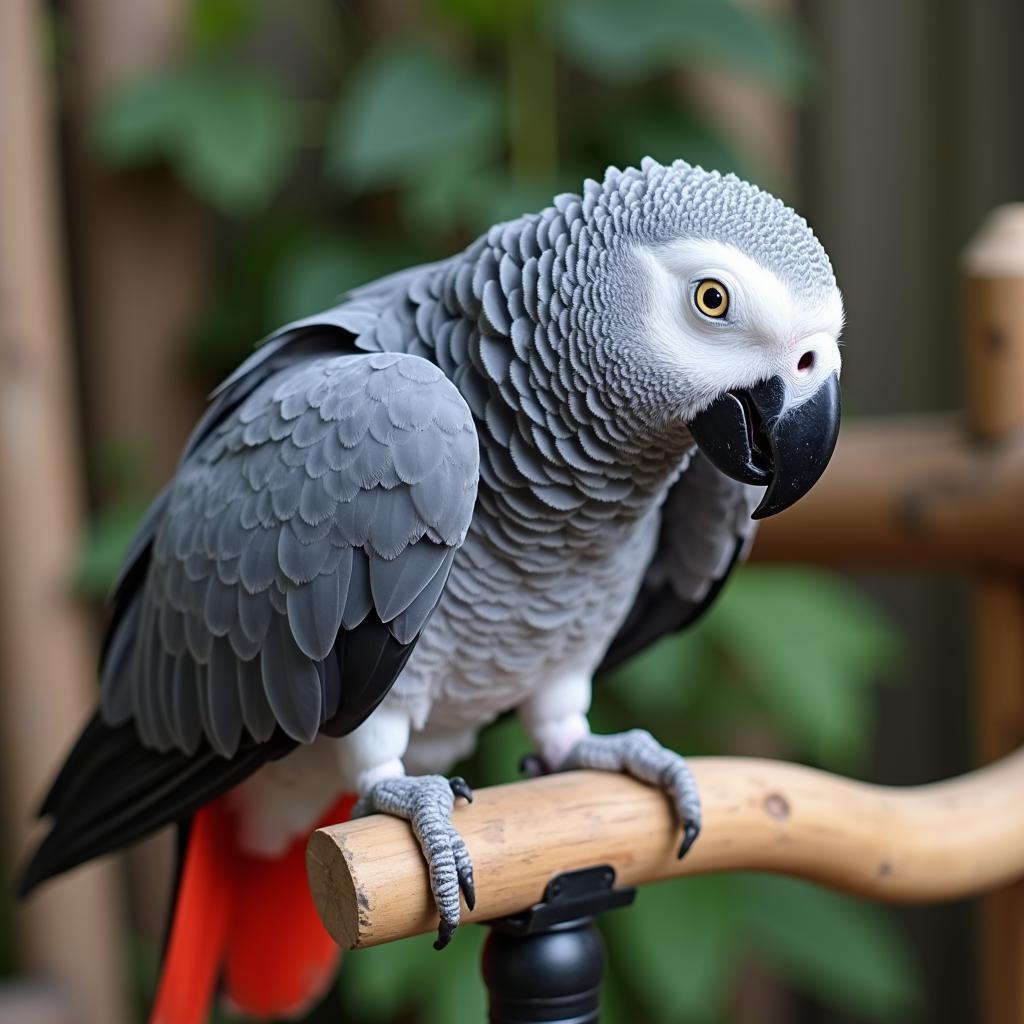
[25,159,843,1024]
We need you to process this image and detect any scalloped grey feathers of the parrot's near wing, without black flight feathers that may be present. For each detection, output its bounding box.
[103,353,478,757]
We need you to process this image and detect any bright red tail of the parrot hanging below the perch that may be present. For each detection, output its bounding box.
[150,796,355,1024]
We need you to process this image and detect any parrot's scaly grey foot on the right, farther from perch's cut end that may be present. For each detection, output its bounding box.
[561,729,700,858]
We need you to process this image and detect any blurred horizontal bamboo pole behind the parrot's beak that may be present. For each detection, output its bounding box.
[753,415,1024,572]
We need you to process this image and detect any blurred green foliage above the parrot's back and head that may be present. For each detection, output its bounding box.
[93,0,812,377]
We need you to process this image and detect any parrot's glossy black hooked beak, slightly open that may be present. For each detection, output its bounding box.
[689,374,841,519]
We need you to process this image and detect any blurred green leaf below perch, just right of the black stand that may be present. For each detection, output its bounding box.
[603,876,742,1021]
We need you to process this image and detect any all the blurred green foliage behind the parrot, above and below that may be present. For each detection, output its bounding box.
[80,0,916,1024]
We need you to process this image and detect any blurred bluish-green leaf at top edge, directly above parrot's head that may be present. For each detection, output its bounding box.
[555,0,810,92]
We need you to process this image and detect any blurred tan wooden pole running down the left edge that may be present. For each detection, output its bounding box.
[0,0,127,1024]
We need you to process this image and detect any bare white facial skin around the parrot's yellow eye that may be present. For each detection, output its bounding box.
[638,241,843,421]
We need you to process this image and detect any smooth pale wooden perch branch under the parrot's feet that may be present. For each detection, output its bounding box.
[307,750,1024,948]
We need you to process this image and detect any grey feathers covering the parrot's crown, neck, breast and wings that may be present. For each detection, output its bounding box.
[103,155,815,755]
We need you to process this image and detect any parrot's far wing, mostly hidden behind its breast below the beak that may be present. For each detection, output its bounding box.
[598,452,764,672]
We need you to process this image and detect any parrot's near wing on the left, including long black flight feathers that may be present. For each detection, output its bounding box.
[23,348,479,889]
